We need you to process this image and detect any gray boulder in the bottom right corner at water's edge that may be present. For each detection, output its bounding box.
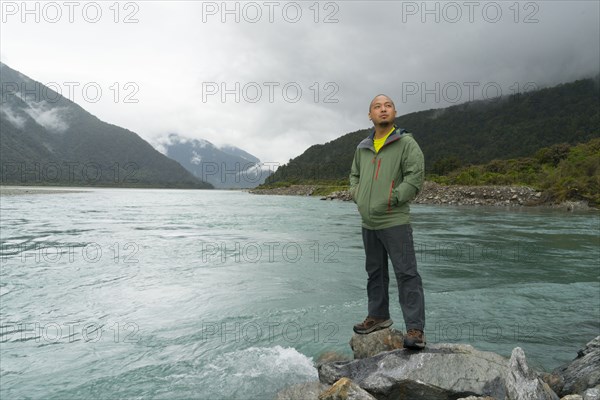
[552,336,600,396]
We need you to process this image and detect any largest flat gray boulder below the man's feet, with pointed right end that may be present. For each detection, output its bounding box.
[318,344,558,400]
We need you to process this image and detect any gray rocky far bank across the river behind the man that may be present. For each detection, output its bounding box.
[250,181,589,211]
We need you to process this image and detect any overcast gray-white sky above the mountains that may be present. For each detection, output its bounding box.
[0,0,600,163]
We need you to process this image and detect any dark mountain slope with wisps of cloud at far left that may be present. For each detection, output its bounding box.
[0,63,212,188]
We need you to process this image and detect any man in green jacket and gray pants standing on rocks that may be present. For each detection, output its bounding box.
[350,94,426,349]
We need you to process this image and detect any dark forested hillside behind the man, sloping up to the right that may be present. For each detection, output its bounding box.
[266,76,600,184]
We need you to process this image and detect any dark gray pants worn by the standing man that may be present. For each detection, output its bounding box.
[362,224,425,330]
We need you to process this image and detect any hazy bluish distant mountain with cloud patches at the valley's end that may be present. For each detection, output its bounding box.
[156,133,271,189]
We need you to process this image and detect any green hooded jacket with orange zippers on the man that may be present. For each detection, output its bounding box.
[350,127,425,229]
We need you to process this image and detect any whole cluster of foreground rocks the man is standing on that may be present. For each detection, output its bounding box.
[276,328,600,400]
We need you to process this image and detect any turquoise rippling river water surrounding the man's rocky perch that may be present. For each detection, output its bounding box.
[0,188,600,399]
